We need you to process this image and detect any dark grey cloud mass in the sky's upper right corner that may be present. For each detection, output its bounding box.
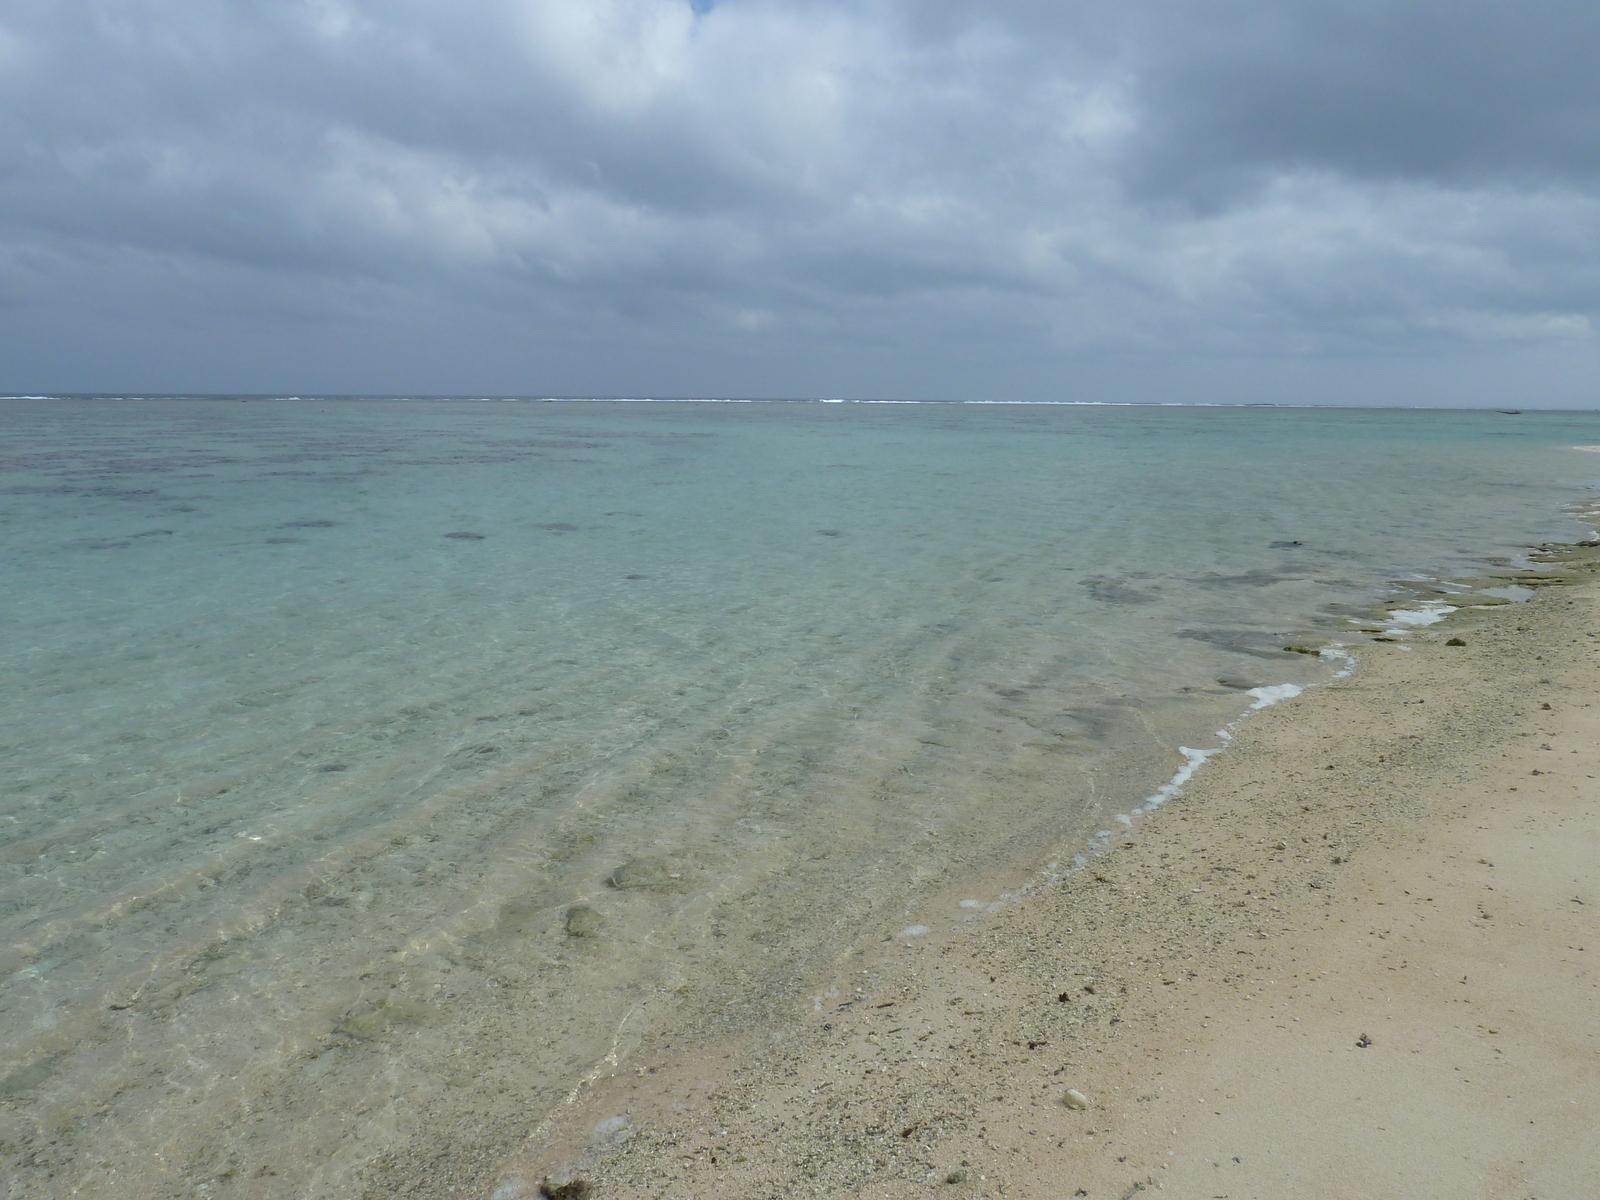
[1136,0,1600,202]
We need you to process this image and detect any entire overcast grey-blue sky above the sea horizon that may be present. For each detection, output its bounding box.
[0,0,1600,408]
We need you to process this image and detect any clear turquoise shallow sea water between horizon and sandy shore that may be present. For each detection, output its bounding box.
[9,398,1600,1195]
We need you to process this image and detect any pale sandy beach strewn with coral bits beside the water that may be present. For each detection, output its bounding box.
[494,562,1600,1200]
